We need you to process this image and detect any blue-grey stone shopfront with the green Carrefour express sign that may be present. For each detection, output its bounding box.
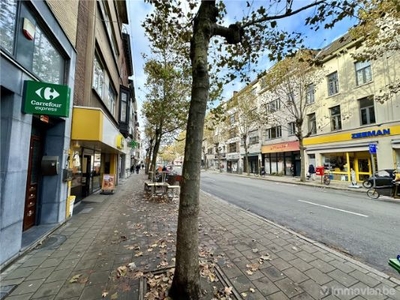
[0,1,76,265]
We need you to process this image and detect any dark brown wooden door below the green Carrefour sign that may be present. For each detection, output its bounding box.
[23,133,42,231]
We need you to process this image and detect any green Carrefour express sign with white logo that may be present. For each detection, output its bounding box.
[22,80,71,117]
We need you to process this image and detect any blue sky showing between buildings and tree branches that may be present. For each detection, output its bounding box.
[126,0,355,126]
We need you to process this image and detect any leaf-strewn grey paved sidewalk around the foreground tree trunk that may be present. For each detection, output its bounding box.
[1,175,400,300]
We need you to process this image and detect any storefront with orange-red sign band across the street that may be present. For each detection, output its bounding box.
[261,141,301,176]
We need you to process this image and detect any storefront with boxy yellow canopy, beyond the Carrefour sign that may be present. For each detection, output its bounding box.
[71,107,123,202]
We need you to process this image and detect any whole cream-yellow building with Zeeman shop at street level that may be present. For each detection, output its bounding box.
[304,34,400,182]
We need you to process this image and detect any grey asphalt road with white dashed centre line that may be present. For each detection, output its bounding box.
[201,172,400,274]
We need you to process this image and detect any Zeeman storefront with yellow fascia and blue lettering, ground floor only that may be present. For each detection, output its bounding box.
[304,124,400,182]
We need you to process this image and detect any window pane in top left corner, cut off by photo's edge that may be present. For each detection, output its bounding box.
[0,0,17,54]
